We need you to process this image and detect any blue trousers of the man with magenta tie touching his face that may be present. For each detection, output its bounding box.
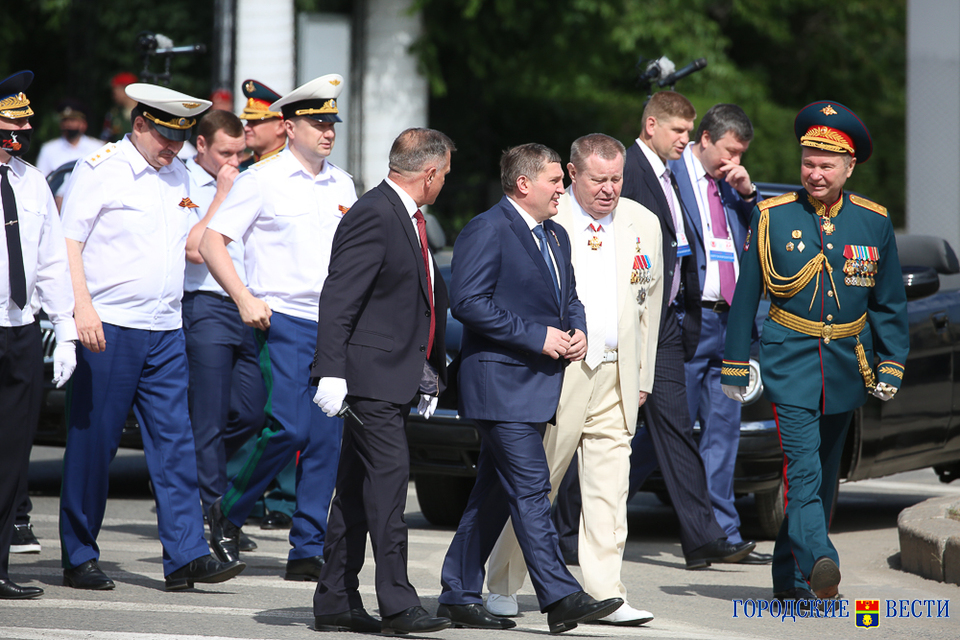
[683,309,743,544]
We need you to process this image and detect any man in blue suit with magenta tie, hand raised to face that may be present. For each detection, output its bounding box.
[669,104,773,564]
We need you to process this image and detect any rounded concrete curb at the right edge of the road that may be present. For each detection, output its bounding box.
[897,496,960,584]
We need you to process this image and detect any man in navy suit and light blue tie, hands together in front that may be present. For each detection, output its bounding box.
[437,143,623,633]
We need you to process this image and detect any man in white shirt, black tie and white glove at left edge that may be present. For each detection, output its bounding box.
[0,71,77,600]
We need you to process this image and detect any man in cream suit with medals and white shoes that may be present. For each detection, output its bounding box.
[486,133,663,626]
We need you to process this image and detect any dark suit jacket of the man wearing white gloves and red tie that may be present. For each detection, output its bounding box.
[311,182,449,404]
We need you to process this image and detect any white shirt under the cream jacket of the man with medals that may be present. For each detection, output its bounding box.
[570,199,620,350]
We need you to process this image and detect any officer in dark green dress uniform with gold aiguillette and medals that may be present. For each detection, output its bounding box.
[721,101,909,599]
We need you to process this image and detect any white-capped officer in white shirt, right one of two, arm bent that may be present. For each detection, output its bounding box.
[200,74,357,580]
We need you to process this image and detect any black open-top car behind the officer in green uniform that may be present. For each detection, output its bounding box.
[407,184,960,538]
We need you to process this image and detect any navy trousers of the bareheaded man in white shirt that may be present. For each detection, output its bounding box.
[183,291,266,513]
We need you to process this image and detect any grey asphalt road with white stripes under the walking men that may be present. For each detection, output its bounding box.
[0,447,960,640]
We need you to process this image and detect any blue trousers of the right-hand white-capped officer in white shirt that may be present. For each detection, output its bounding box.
[221,313,343,560]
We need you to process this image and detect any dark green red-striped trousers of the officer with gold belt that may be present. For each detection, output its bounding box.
[773,404,853,593]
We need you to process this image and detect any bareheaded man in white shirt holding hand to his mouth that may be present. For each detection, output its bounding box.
[183,110,266,550]
